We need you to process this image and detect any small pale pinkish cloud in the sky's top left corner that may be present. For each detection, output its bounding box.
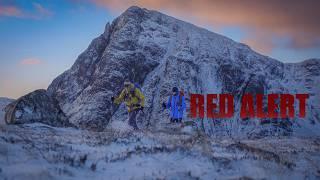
[0,3,53,19]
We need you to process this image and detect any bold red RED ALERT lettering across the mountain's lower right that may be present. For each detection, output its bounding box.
[190,94,309,118]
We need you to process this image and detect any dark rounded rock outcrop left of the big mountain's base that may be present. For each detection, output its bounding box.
[5,89,71,127]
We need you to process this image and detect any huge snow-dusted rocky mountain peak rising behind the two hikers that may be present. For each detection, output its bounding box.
[3,7,320,133]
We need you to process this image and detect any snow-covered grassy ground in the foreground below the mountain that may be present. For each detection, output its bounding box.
[0,122,320,179]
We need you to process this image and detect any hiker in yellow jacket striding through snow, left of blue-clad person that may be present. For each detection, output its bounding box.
[111,80,144,130]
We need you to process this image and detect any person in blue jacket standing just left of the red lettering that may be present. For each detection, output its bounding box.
[162,87,186,123]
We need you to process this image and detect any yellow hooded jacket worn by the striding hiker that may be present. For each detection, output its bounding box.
[114,84,144,112]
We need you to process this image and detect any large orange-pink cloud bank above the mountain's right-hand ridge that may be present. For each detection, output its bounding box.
[84,0,320,51]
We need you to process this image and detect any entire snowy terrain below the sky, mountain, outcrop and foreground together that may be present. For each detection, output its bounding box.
[0,7,320,179]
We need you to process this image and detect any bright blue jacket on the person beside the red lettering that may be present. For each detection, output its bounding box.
[166,95,186,119]
